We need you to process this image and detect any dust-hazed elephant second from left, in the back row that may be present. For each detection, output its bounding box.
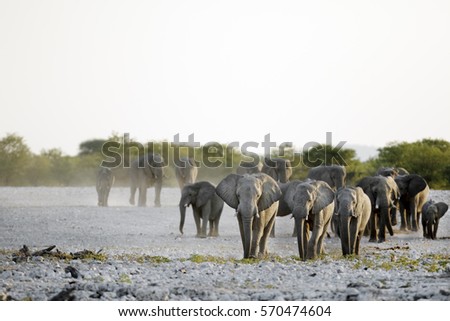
[130,153,165,207]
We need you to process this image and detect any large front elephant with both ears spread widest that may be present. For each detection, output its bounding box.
[216,173,281,258]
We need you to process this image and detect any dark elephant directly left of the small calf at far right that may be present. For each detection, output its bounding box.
[395,174,430,231]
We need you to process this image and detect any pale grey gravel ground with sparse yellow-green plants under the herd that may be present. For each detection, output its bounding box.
[0,187,450,301]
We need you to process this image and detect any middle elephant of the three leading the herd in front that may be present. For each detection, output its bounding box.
[280,180,334,260]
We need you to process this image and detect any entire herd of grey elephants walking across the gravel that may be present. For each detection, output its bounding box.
[97,154,448,260]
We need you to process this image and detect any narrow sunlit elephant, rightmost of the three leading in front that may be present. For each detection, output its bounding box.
[336,187,372,255]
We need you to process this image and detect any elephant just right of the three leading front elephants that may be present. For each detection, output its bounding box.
[357,175,400,243]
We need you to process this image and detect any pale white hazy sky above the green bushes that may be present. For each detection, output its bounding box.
[0,0,450,159]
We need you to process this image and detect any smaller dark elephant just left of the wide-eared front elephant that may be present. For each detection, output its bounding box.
[179,181,224,238]
